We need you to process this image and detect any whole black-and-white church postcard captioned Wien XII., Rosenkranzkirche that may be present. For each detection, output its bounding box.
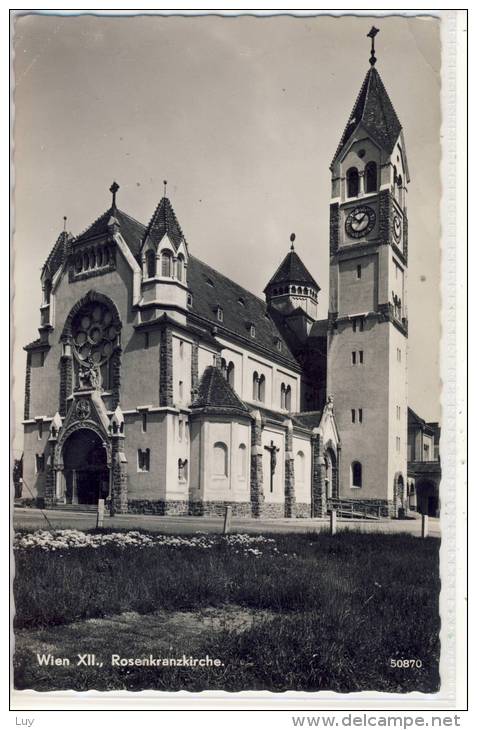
[10,10,465,719]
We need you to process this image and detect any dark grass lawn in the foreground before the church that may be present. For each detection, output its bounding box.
[14,532,440,692]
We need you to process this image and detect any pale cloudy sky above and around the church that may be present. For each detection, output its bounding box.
[12,14,441,455]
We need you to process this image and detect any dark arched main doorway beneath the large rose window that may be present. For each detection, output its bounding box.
[63,428,109,504]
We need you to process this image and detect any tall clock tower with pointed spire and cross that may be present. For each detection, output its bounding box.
[328,27,409,516]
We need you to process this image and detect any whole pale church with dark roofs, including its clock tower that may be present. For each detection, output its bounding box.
[23,29,409,517]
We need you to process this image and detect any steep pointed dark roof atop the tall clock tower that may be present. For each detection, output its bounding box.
[331,66,402,164]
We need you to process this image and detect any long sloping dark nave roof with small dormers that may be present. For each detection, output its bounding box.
[187,255,298,368]
